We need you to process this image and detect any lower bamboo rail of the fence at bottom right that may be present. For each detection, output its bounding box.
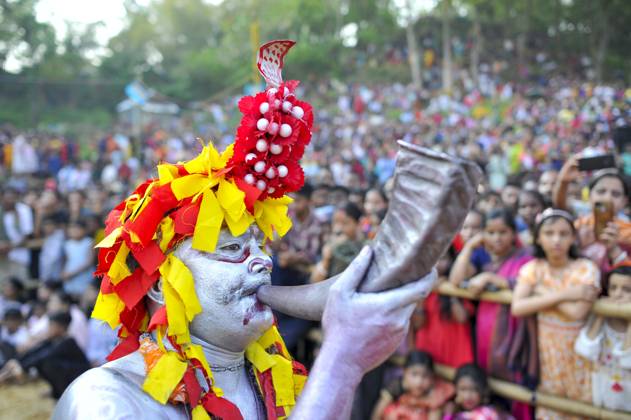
[434,363,631,420]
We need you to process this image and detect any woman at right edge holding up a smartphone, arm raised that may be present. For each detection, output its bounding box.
[554,155,631,273]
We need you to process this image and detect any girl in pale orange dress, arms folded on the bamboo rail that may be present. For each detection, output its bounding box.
[512,209,600,418]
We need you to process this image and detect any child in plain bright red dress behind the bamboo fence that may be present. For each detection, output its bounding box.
[412,248,474,367]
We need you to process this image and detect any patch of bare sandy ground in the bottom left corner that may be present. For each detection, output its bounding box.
[0,380,55,420]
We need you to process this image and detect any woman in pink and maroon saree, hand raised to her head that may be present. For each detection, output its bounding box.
[449,209,537,419]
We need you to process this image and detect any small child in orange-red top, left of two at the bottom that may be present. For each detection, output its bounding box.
[372,351,454,420]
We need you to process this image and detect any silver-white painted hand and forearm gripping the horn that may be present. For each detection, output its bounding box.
[291,247,436,420]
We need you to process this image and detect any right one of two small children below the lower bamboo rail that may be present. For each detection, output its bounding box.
[443,363,513,420]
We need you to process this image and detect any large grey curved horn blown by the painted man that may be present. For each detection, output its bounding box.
[257,141,482,320]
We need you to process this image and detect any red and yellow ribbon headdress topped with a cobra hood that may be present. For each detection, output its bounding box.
[92,41,313,420]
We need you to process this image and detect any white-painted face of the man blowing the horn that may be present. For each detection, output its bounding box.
[175,228,273,351]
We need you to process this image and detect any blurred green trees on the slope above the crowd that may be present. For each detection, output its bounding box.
[0,0,631,125]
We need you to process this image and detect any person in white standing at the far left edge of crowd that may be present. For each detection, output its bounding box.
[2,189,33,280]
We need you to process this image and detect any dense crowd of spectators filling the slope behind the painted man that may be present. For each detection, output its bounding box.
[0,70,631,419]
